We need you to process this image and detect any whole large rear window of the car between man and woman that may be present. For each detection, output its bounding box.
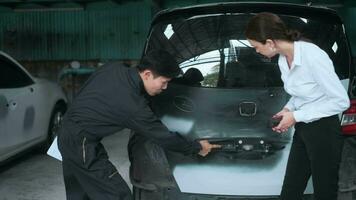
[146,14,350,88]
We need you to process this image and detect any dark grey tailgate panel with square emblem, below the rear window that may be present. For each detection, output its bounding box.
[152,84,289,141]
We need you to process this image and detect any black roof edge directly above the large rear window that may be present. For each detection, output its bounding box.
[152,2,342,25]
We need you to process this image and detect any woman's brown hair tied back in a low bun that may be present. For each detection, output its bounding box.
[245,12,301,44]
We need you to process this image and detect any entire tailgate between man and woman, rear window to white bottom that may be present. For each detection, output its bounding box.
[132,3,350,196]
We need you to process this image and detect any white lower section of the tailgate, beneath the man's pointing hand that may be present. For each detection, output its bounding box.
[173,144,313,196]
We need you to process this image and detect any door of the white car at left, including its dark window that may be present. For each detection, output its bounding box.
[0,55,36,161]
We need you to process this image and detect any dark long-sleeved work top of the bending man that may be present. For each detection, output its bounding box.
[66,63,200,154]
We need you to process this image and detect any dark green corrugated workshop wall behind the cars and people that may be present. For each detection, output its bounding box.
[0,0,356,90]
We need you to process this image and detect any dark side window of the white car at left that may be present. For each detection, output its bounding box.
[0,57,33,89]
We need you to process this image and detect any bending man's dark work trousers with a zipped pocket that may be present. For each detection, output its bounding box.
[58,120,132,200]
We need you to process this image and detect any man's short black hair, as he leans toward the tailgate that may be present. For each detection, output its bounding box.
[137,50,182,78]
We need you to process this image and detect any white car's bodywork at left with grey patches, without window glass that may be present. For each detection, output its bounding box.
[0,52,66,161]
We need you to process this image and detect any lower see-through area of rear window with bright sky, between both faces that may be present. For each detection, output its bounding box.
[180,39,283,88]
